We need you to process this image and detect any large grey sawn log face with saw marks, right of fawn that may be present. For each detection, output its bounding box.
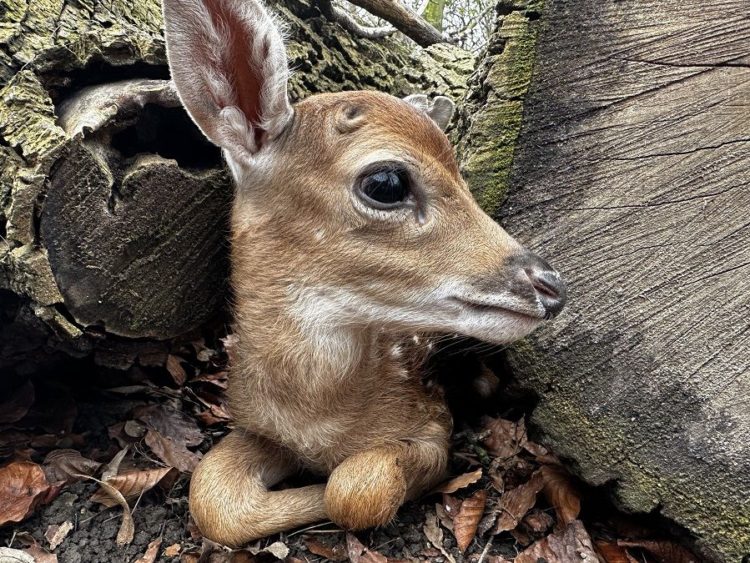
[498,0,750,562]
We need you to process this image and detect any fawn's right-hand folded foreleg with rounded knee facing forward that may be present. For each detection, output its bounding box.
[325,428,448,530]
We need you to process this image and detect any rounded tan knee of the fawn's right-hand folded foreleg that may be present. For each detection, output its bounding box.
[325,450,406,530]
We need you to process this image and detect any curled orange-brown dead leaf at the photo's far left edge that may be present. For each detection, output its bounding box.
[0,461,59,526]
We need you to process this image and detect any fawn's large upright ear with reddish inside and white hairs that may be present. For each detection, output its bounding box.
[164,0,292,163]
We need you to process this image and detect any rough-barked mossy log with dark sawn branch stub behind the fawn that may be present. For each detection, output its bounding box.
[0,0,473,367]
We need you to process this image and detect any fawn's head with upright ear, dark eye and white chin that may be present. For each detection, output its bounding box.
[164,0,565,343]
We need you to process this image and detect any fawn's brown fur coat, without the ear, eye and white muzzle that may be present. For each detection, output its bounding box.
[190,92,560,545]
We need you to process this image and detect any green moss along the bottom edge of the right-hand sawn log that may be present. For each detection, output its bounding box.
[508,340,750,561]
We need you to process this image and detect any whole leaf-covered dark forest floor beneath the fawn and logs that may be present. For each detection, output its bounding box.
[0,337,701,563]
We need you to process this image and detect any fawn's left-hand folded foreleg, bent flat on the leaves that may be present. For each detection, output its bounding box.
[190,430,326,546]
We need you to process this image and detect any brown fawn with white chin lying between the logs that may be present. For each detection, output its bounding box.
[164,0,565,545]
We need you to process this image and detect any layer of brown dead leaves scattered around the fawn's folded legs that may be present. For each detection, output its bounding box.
[0,336,700,563]
